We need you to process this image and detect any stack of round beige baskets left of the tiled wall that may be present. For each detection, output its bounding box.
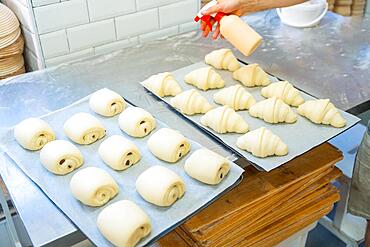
[0,3,25,79]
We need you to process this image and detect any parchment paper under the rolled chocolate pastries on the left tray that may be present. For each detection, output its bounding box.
[1,97,243,247]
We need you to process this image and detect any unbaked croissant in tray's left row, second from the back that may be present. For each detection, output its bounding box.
[170,89,212,115]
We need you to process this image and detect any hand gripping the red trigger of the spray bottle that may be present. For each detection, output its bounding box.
[200,0,245,39]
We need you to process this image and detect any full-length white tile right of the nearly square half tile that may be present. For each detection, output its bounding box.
[67,19,116,51]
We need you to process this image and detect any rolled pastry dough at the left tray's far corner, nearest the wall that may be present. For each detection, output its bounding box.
[89,88,126,117]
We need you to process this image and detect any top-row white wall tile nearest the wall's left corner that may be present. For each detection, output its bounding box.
[34,0,89,34]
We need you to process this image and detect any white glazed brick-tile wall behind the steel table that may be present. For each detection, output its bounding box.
[0,0,200,69]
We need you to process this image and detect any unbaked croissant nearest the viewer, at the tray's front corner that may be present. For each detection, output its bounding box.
[236,127,288,158]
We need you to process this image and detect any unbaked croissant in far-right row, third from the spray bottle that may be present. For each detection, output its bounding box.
[261,81,304,106]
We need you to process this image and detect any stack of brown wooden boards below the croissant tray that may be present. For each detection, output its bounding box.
[157,143,342,246]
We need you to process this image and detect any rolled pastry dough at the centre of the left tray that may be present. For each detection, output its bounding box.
[98,135,141,171]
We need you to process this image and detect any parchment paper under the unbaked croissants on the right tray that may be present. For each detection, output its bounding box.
[145,62,360,171]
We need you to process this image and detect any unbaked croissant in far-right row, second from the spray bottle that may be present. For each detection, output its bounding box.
[233,63,270,87]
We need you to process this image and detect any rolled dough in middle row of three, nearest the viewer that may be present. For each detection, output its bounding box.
[136,166,185,207]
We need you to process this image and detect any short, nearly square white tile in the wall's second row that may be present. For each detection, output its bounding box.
[40,30,69,59]
